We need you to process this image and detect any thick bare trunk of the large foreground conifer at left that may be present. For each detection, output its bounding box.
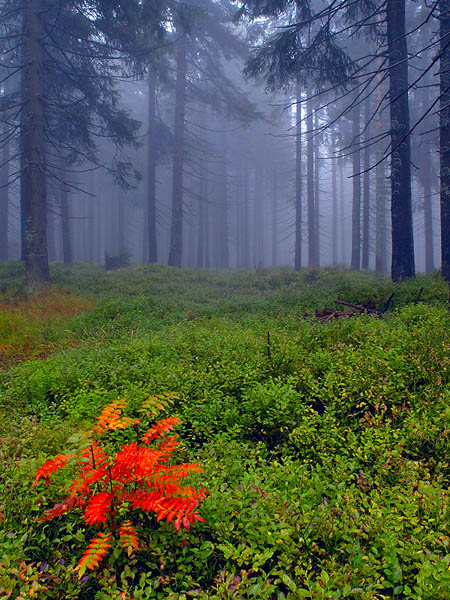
[21,0,50,292]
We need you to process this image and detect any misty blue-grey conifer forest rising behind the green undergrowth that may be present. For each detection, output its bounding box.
[0,0,450,290]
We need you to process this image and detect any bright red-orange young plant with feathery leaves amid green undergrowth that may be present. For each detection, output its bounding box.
[33,395,207,577]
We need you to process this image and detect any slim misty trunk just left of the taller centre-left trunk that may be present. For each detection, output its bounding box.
[147,69,158,264]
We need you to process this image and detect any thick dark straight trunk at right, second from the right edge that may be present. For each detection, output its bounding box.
[386,0,415,281]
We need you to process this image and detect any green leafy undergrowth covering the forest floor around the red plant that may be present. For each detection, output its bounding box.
[0,263,450,600]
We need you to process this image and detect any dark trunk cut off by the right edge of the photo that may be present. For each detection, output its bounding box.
[439,0,450,285]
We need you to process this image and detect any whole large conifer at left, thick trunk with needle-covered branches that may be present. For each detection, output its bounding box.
[0,0,163,290]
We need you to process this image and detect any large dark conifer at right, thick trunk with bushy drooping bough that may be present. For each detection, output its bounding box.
[240,0,415,280]
